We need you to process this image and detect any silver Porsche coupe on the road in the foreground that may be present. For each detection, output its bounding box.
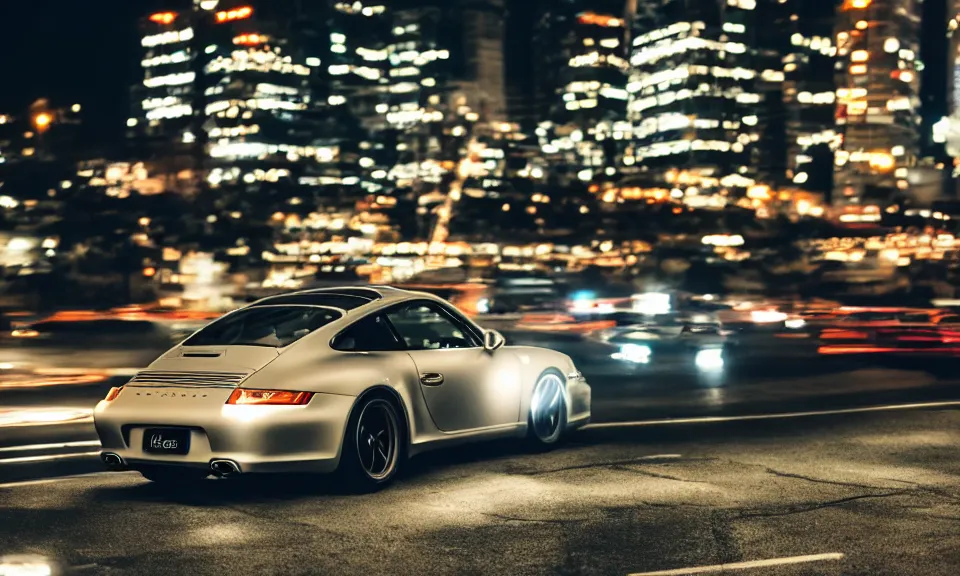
[94,287,590,489]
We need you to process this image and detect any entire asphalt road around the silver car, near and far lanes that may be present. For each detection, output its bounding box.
[0,338,960,576]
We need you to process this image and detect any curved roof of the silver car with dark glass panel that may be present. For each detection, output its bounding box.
[247,286,440,313]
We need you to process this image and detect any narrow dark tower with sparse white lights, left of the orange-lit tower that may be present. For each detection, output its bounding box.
[770,0,840,197]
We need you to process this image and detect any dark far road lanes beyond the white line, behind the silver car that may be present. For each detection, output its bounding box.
[0,333,960,482]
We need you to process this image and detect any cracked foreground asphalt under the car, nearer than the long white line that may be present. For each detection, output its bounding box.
[0,410,960,576]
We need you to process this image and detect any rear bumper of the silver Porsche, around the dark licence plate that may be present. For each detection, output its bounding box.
[94,387,356,473]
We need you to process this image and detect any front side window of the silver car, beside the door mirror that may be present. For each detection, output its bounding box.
[387,303,480,350]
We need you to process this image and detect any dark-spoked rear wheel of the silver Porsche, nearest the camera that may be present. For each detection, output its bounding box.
[337,394,405,493]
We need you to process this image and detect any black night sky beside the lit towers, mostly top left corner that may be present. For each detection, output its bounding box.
[0,0,947,153]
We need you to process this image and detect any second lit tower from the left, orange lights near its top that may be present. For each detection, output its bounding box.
[201,1,334,199]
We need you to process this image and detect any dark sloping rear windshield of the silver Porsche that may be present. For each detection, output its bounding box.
[183,306,340,348]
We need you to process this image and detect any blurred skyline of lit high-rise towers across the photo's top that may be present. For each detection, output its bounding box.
[0,0,949,225]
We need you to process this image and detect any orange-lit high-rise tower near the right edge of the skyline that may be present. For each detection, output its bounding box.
[834,0,920,204]
